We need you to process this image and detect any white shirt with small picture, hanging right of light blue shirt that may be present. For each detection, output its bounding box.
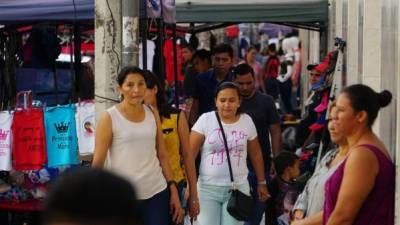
[76,101,95,155]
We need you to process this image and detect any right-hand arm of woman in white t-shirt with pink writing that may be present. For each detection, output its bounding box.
[247,138,269,201]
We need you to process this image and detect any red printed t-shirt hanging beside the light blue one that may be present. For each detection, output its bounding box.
[12,109,47,170]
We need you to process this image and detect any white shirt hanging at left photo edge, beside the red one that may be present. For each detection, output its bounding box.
[0,111,13,171]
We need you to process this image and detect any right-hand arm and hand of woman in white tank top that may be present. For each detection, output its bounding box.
[152,108,183,222]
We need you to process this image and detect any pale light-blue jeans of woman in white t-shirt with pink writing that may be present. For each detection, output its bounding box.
[197,182,250,225]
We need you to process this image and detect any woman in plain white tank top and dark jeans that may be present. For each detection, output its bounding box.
[92,66,183,225]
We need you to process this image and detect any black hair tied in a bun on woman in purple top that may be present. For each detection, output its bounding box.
[342,84,392,127]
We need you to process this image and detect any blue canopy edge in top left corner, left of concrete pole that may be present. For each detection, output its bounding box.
[0,0,94,24]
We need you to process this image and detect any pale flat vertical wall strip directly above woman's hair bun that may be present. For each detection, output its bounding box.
[362,0,382,135]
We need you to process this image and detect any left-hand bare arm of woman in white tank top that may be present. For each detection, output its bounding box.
[92,112,113,167]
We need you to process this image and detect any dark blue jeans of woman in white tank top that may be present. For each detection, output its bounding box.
[141,188,170,225]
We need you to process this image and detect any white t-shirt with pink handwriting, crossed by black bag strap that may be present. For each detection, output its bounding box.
[192,111,257,186]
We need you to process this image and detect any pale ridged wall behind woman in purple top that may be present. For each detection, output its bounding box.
[329,0,400,225]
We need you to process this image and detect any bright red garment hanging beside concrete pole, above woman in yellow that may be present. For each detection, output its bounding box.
[164,39,183,84]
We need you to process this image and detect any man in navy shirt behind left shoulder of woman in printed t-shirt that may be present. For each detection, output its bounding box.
[189,44,233,125]
